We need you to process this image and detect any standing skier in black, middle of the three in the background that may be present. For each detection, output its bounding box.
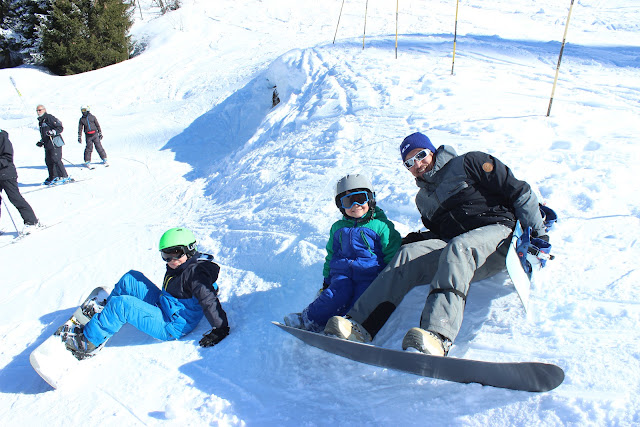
[36,104,71,185]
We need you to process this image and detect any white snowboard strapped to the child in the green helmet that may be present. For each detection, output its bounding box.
[29,286,111,389]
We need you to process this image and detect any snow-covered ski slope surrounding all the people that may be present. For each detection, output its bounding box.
[0,0,640,426]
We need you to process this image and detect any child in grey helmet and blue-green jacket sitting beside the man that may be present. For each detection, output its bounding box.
[284,174,401,332]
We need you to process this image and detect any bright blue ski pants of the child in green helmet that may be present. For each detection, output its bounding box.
[84,270,176,346]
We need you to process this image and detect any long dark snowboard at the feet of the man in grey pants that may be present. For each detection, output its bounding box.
[272,322,564,392]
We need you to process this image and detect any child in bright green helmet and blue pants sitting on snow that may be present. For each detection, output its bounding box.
[66,228,229,358]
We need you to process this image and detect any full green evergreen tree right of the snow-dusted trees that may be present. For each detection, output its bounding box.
[42,0,132,75]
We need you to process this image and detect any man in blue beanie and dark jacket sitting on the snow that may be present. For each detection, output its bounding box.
[325,132,548,356]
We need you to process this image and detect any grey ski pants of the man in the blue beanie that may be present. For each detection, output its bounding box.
[347,224,512,342]
